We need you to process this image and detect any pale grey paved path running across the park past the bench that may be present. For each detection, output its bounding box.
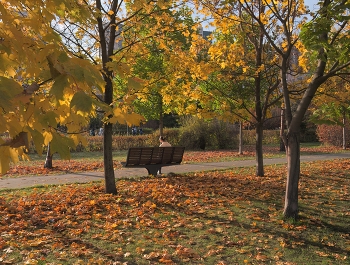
[0,153,350,191]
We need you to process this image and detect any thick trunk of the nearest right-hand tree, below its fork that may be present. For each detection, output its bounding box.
[283,132,300,219]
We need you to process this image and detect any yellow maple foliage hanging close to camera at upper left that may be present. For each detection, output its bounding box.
[0,1,103,173]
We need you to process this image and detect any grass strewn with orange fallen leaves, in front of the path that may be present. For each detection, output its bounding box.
[0,159,350,265]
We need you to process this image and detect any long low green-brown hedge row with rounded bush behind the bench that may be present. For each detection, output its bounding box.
[5,128,318,153]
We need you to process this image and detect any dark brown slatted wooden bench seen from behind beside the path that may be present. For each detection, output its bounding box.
[122,146,185,176]
